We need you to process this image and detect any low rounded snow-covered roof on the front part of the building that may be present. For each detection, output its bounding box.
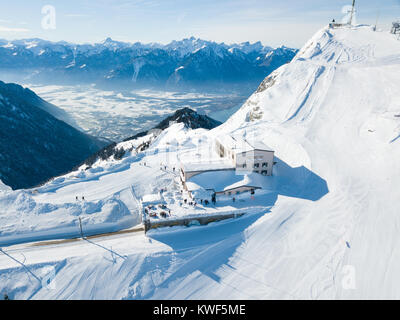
[186,170,266,192]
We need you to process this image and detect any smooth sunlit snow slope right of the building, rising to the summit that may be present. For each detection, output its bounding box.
[212,26,400,299]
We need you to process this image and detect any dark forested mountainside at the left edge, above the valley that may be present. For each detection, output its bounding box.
[0,81,106,189]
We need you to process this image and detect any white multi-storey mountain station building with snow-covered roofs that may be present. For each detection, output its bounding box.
[180,135,274,197]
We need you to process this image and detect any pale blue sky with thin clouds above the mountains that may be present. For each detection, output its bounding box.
[0,0,400,47]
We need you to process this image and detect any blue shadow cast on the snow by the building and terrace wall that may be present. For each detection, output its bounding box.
[145,158,329,298]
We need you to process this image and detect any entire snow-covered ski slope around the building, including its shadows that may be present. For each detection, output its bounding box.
[0,26,400,299]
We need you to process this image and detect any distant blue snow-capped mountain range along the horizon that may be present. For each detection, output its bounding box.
[0,37,297,89]
